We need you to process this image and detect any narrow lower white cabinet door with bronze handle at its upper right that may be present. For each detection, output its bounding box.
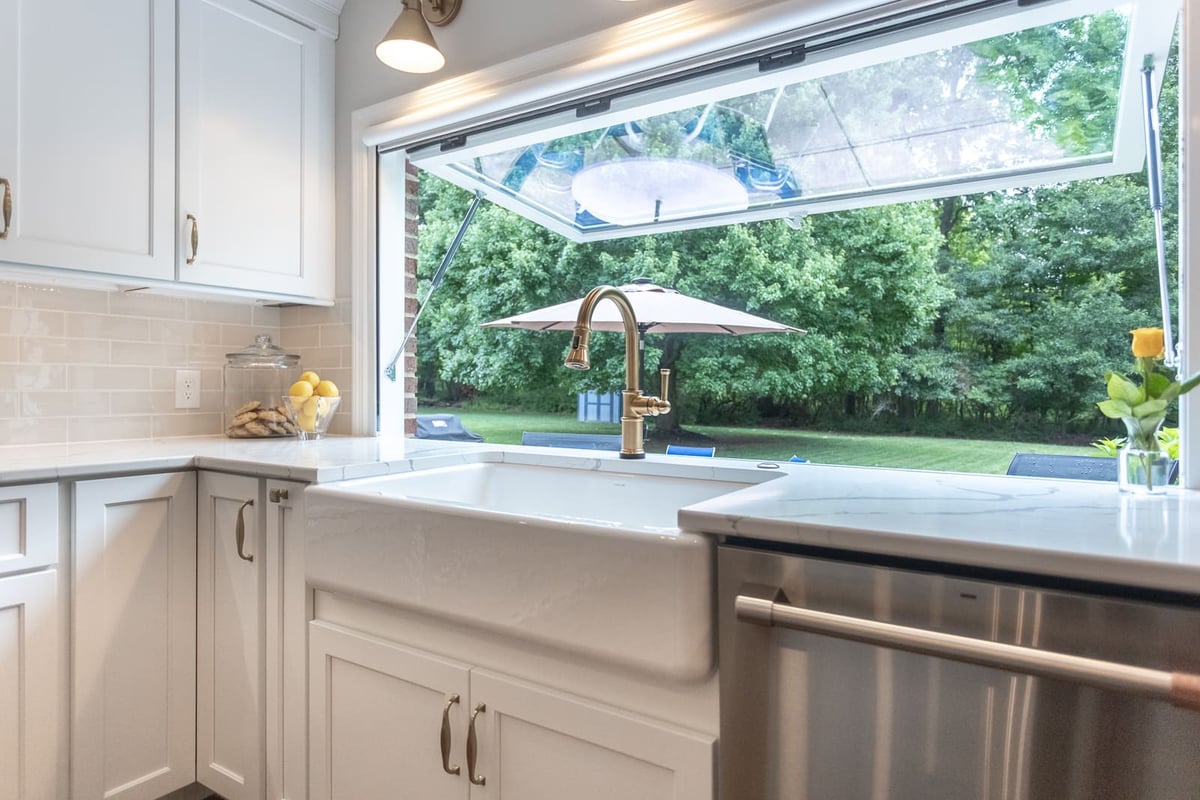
[196,473,266,800]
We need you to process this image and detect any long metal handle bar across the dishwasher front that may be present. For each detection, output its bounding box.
[733,584,1200,711]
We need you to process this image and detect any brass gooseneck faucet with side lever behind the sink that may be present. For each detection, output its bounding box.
[564,285,671,458]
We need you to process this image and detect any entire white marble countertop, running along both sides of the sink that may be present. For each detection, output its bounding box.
[0,435,1200,596]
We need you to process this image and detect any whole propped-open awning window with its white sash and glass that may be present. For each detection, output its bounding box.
[409,0,1177,241]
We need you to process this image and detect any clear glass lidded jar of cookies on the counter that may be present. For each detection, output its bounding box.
[224,333,300,439]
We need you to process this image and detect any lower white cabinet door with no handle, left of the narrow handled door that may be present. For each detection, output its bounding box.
[71,473,196,800]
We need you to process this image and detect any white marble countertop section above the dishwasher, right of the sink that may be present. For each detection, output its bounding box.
[679,464,1200,595]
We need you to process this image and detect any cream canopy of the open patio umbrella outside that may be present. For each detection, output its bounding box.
[484,278,806,338]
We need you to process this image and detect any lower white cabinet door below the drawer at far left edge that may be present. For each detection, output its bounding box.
[0,570,59,800]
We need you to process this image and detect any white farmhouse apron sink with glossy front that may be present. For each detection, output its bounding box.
[305,452,772,680]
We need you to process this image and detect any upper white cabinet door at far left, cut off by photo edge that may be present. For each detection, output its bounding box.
[0,0,175,278]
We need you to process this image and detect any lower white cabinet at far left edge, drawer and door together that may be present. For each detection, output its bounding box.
[0,483,62,800]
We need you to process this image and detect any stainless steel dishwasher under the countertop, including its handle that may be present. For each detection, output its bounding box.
[718,543,1200,800]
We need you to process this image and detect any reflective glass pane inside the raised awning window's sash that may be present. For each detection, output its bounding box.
[436,10,1129,233]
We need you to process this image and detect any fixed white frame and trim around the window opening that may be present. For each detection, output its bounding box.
[350,0,1200,489]
